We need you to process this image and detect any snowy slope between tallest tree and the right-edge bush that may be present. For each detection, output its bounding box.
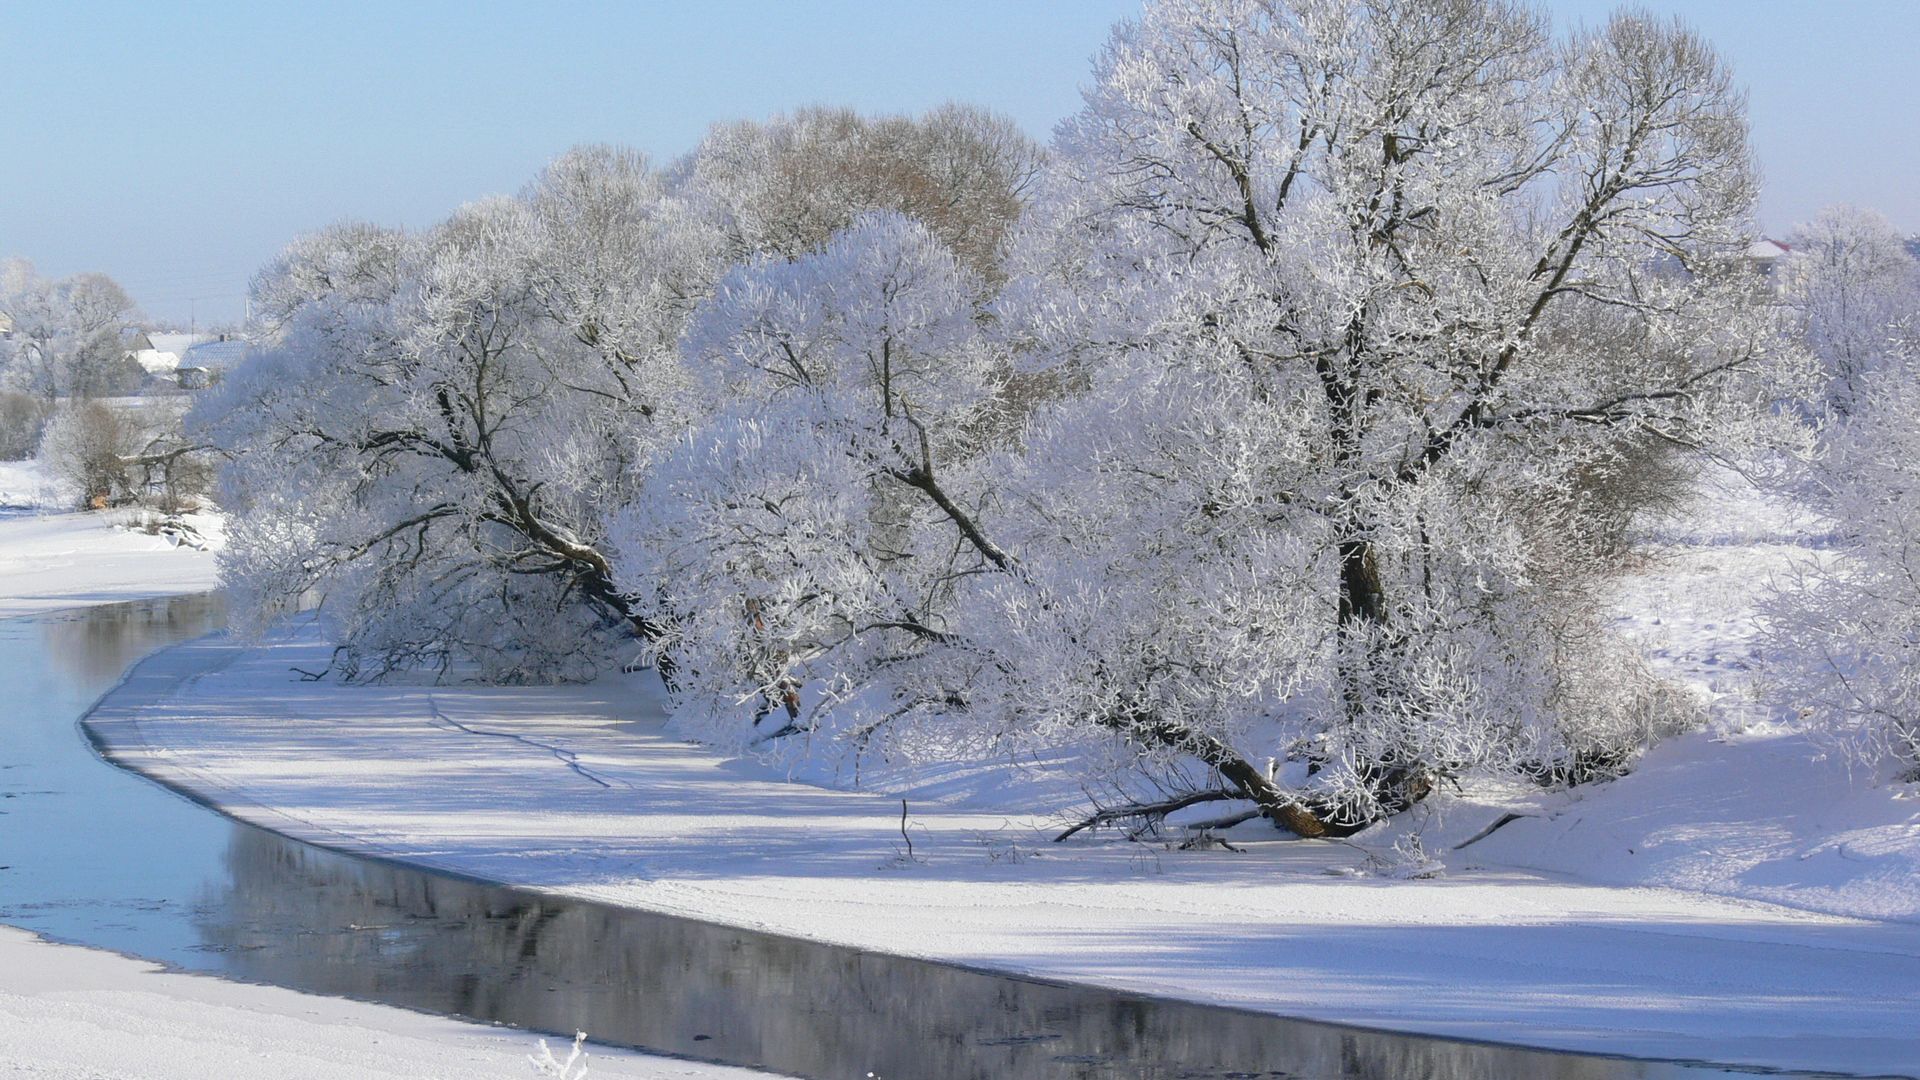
[1473,477,1920,914]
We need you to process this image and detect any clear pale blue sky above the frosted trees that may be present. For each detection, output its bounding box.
[0,0,1920,325]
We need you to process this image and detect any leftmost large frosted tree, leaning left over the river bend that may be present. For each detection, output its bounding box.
[196,148,714,678]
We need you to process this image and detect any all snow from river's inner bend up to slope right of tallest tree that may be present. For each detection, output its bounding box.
[74,472,1920,1074]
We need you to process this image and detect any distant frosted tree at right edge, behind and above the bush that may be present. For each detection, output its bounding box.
[1778,206,1920,415]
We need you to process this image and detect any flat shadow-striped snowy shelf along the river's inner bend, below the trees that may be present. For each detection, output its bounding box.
[71,622,1920,1074]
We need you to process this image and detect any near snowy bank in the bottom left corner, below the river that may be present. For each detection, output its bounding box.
[0,914,766,1080]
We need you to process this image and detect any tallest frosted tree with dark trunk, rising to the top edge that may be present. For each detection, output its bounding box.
[1006,0,1788,834]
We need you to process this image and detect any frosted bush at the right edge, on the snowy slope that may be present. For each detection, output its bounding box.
[1764,371,1920,769]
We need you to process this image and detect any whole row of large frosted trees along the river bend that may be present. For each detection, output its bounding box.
[198,0,1881,836]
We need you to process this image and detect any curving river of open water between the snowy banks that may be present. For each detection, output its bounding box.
[0,596,1858,1080]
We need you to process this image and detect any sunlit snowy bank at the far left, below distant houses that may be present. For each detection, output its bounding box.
[0,461,219,619]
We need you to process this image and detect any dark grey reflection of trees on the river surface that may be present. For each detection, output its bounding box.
[204,828,1690,1080]
